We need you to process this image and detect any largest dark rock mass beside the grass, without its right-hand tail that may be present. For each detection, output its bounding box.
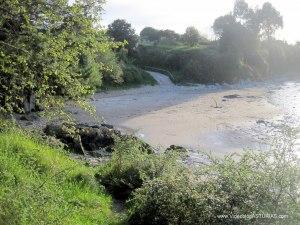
[44,123,120,156]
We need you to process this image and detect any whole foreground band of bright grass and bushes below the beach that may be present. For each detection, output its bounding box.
[0,118,300,225]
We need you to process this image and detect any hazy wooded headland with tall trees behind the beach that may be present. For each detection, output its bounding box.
[136,0,300,83]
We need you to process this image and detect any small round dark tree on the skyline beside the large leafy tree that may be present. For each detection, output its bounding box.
[107,19,138,53]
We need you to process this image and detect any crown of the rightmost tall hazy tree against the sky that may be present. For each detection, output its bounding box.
[257,2,283,40]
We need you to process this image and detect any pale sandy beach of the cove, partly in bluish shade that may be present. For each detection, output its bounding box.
[93,73,300,153]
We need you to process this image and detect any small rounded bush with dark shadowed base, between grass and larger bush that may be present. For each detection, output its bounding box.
[97,138,173,199]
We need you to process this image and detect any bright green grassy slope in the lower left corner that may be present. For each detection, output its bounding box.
[0,130,123,225]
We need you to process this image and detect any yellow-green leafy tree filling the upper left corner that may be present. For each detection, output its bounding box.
[0,0,116,112]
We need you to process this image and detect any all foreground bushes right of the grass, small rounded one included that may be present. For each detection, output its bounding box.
[97,127,300,225]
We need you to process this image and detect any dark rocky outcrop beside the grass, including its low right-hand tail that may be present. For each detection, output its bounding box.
[44,123,154,157]
